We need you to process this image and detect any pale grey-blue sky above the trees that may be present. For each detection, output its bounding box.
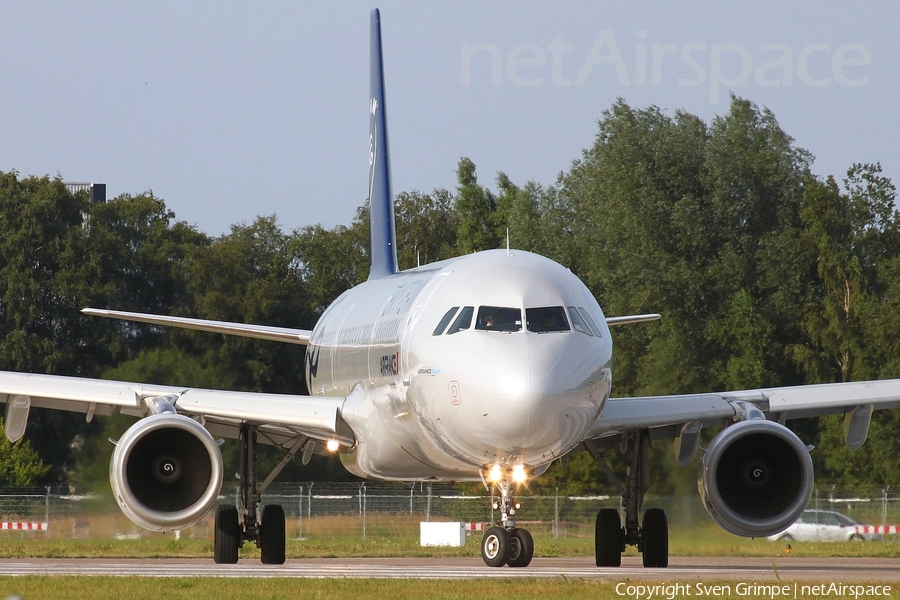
[0,0,900,235]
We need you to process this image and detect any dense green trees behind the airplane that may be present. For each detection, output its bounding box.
[0,97,900,493]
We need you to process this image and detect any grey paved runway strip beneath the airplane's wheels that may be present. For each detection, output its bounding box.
[0,556,900,587]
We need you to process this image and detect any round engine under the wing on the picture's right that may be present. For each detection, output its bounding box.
[698,419,813,537]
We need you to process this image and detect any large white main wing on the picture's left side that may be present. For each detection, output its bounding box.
[0,371,354,446]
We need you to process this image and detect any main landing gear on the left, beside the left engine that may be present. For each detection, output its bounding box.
[213,424,311,565]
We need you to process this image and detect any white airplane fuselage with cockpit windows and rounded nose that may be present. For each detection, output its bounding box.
[306,250,612,480]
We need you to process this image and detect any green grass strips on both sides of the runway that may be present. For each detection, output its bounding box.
[0,522,900,600]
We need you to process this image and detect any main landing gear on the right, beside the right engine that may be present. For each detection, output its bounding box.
[586,430,669,567]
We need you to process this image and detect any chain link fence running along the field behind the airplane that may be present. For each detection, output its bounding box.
[0,482,900,541]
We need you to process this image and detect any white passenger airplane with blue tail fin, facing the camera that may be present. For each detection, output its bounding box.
[0,9,900,568]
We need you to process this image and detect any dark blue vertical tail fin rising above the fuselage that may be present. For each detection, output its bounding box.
[369,8,399,279]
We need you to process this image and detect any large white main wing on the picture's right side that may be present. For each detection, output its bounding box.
[592,379,900,438]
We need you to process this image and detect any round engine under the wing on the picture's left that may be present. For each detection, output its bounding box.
[109,413,223,531]
